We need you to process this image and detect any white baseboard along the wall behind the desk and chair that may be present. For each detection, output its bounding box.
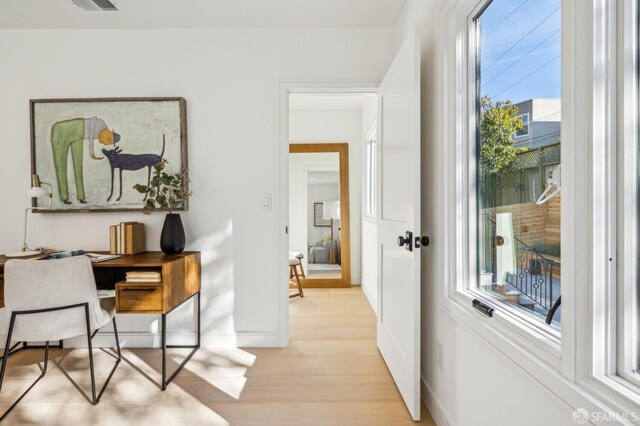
[0,331,278,348]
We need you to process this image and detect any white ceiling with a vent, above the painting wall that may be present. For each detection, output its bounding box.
[0,0,405,29]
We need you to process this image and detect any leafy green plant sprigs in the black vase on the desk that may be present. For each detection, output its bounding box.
[133,158,193,214]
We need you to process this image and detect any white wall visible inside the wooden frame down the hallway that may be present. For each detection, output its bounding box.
[289,152,340,271]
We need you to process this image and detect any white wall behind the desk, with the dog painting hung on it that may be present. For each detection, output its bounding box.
[0,29,393,346]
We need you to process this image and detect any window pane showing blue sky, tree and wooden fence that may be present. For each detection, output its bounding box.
[474,0,561,327]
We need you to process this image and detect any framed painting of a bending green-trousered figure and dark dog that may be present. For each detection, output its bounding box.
[30,98,188,212]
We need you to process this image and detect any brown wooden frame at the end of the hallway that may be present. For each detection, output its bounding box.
[289,142,351,288]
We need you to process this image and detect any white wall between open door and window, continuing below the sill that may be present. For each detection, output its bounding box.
[396,0,573,426]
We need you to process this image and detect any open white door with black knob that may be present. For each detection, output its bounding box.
[378,27,420,420]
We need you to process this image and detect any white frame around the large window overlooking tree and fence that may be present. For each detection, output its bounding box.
[437,0,640,415]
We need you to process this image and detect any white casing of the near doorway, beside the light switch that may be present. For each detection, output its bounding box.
[276,81,380,348]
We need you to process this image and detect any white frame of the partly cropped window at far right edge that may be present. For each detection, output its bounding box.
[575,0,640,410]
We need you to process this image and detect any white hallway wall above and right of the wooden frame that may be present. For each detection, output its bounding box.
[289,108,362,284]
